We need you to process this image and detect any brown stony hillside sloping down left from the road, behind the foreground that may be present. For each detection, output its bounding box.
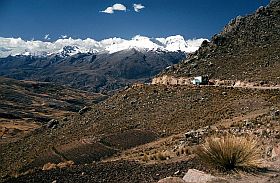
[0,83,279,181]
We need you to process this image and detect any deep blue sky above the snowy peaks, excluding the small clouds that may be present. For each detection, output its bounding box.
[0,0,269,41]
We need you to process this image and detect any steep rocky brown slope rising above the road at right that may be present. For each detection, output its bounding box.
[161,0,280,84]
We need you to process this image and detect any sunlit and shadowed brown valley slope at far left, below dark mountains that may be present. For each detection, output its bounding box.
[0,77,107,143]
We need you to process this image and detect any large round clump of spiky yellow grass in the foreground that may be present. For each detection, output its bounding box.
[195,135,261,171]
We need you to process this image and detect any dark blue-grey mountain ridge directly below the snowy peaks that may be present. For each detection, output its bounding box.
[0,46,186,92]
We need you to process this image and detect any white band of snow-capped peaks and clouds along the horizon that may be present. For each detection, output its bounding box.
[0,35,206,58]
